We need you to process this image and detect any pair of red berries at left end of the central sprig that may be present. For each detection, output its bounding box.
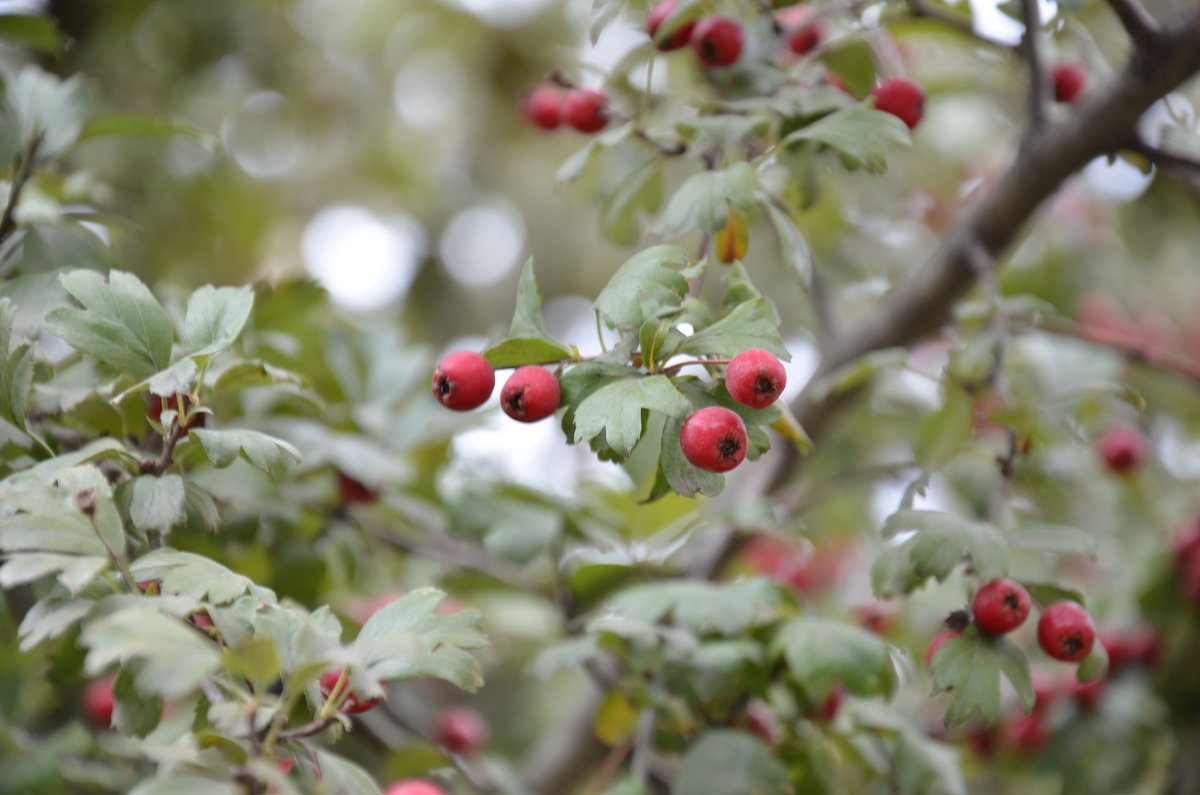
[433,351,563,423]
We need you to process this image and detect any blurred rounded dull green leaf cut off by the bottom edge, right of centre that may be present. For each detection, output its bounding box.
[671,729,791,795]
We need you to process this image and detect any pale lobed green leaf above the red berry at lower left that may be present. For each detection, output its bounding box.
[354,588,486,692]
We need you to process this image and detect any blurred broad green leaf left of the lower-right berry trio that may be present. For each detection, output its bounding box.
[770,617,896,701]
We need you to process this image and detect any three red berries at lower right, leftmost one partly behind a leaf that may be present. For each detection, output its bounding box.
[925,579,1096,664]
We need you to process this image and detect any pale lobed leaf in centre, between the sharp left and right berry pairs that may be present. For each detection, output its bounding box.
[572,376,691,455]
